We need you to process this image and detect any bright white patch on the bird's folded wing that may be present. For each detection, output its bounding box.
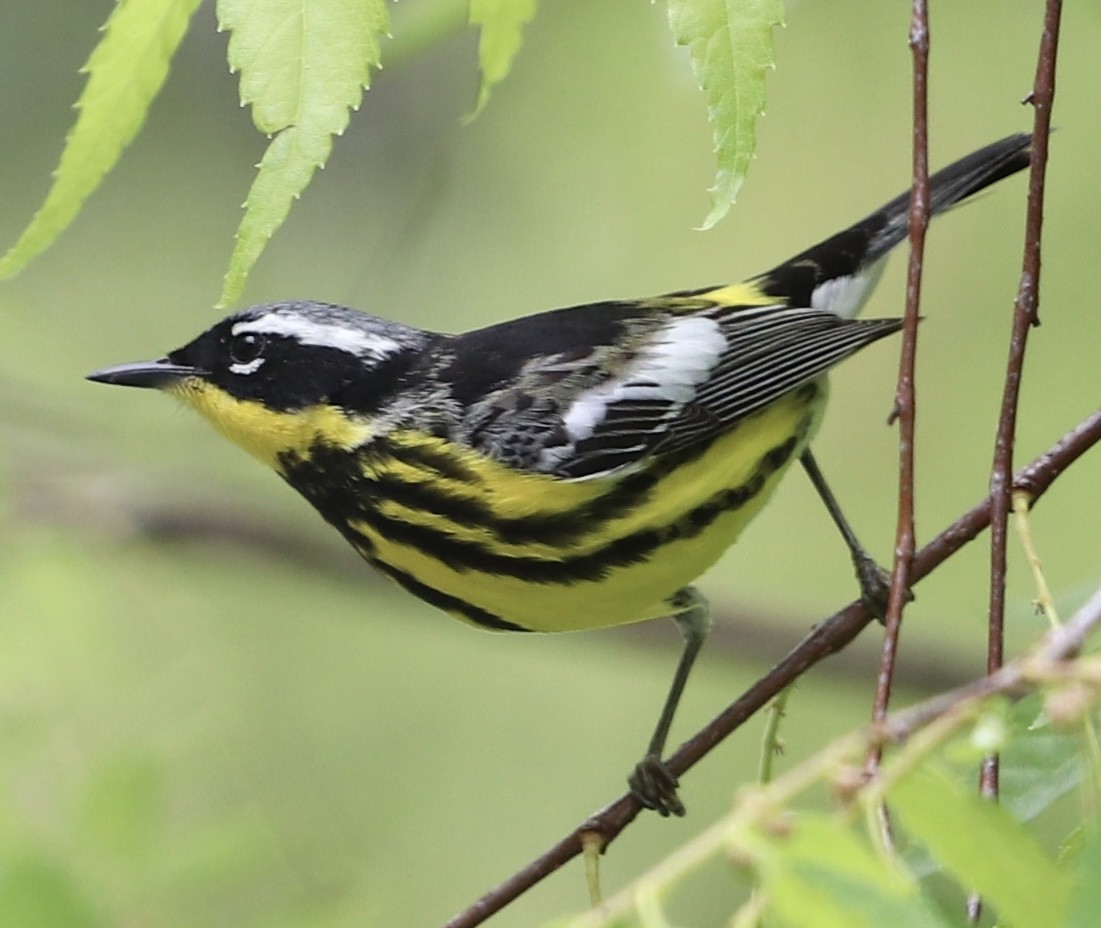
[563,316,727,441]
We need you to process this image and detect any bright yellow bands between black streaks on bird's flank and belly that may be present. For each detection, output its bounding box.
[352,379,826,632]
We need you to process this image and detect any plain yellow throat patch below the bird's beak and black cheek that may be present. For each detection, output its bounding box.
[167,376,371,473]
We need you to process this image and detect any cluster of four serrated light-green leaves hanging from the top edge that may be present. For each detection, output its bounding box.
[0,0,782,305]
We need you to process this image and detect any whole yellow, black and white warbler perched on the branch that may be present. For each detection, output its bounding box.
[89,135,1029,815]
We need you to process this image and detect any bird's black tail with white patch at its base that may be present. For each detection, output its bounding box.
[755,133,1032,315]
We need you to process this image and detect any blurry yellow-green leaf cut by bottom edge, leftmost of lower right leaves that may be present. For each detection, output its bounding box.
[762,814,946,928]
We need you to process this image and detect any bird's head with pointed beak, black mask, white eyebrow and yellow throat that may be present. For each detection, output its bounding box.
[88,303,433,465]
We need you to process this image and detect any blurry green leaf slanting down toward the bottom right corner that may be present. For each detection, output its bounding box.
[889,766,1070,925]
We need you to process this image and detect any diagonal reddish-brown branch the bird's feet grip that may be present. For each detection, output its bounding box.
[445,410,1101,928]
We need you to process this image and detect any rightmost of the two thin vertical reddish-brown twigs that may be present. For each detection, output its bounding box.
[968,0,1062,922]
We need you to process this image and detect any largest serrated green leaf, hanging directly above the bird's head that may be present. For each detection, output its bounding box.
[218,0,389,305]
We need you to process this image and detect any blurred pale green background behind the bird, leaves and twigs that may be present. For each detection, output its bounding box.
[0,0,1101,928]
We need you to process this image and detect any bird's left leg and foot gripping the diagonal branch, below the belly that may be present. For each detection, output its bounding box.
[628,587,711,817]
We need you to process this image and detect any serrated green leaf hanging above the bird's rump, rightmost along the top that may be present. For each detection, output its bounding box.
[668,0,784,229]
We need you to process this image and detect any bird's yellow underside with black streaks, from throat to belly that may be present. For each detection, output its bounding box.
[173,379,826,632]
